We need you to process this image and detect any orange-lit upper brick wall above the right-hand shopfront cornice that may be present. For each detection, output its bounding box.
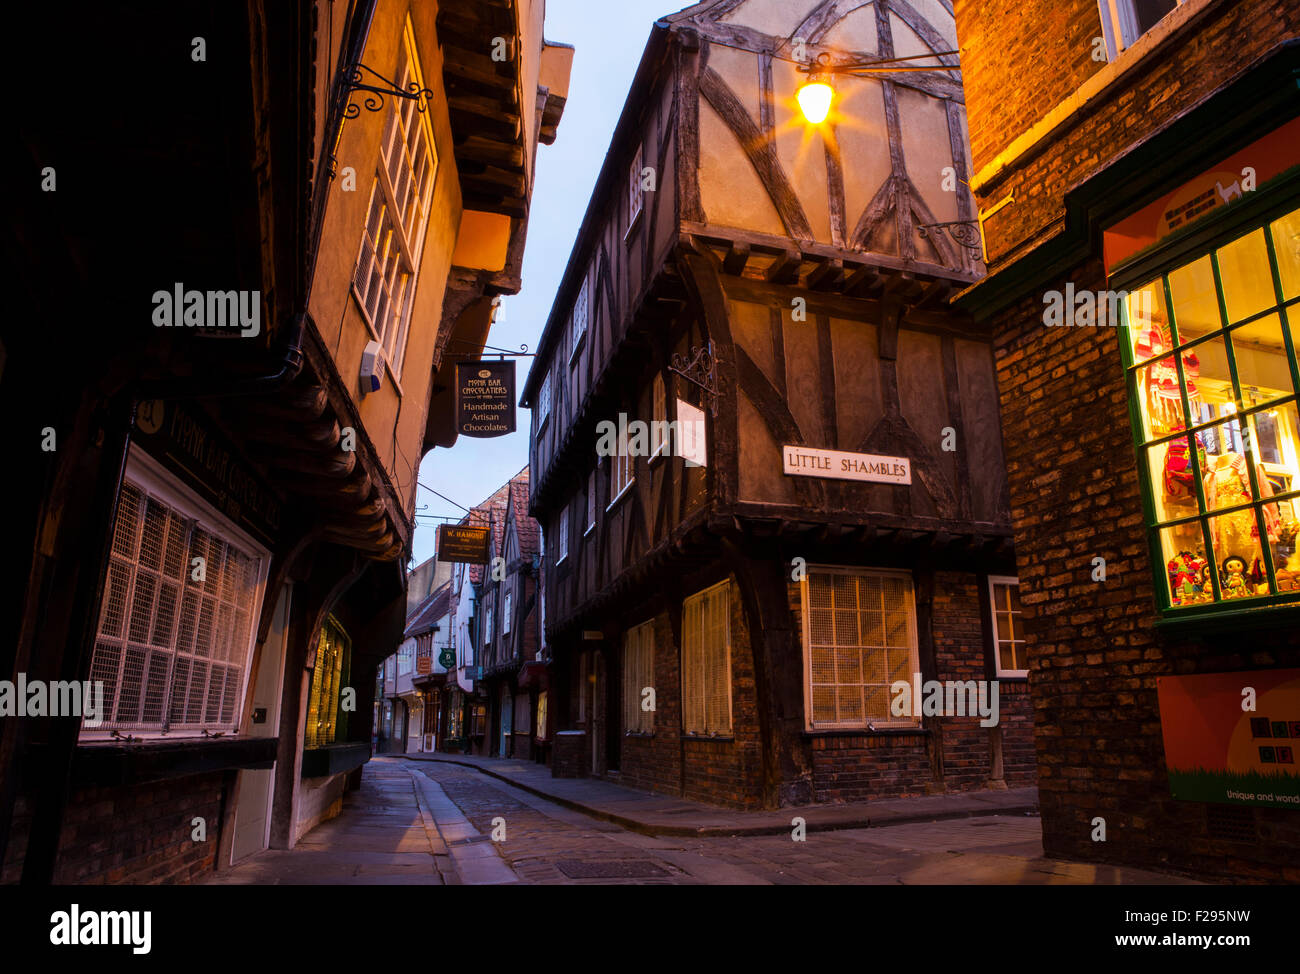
[954,0,1300,267]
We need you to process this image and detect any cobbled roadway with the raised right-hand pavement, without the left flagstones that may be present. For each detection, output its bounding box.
[400,759,1186,886]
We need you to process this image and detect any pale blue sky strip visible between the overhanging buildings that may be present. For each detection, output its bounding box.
[415,0,689,563]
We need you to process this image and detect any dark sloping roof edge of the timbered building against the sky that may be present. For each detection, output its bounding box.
[519,18,672,410]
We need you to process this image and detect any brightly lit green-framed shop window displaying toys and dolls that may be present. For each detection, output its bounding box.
[1122,211,1300,611]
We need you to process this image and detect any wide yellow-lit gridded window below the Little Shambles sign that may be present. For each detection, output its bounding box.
[802,568,919,728]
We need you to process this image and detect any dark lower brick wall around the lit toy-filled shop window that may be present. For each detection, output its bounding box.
[996,269,1300,882]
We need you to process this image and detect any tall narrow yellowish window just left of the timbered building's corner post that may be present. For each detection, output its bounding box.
[681,581,732,736]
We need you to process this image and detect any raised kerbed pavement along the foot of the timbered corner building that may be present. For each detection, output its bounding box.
[402,753,1039,836]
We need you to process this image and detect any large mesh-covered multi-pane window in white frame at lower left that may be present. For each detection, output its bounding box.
[90,472,263,736]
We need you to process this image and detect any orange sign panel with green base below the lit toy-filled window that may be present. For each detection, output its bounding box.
[1156,670,1300,810]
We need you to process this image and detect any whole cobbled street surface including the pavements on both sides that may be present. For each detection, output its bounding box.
[212,758,1184,886]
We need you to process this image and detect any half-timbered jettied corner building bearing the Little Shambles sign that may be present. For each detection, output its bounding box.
[524,0,1034,806]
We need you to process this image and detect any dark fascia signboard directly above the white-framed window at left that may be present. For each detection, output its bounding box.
[131,399,281,547]
